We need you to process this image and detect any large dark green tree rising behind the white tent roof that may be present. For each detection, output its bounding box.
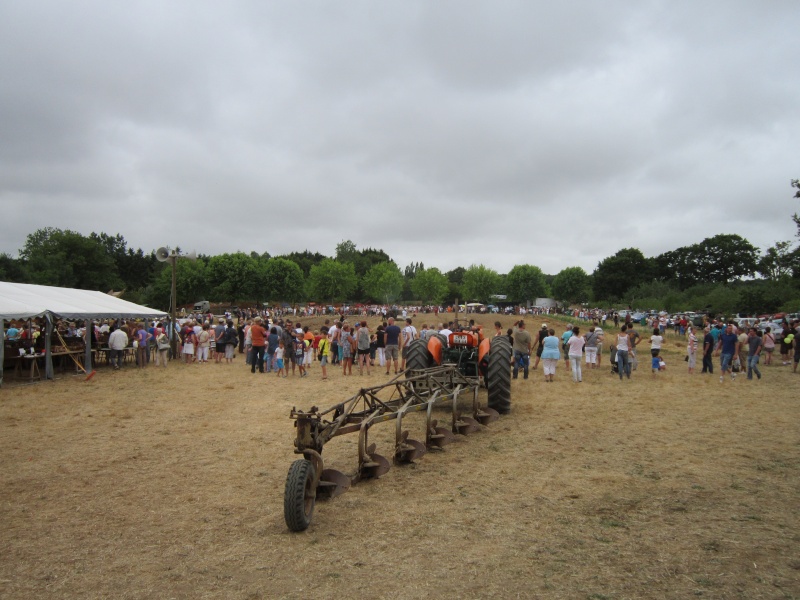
[20,227,122,291]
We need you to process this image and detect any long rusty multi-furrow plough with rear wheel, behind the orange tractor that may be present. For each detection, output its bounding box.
[284,365,499,531]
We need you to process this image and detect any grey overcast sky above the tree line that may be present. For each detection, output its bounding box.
[0,0,800,274]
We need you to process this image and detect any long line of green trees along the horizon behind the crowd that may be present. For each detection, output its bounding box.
[0,193,800,312]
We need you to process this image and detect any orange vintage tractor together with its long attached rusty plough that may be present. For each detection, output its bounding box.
[283,332,511,531]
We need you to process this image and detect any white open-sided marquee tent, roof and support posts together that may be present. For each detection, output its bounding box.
[0,281,172,385]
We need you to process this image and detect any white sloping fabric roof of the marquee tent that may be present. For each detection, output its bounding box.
[0,281,167,320]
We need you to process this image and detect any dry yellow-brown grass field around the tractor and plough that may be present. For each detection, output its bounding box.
[0,316,800,600]
